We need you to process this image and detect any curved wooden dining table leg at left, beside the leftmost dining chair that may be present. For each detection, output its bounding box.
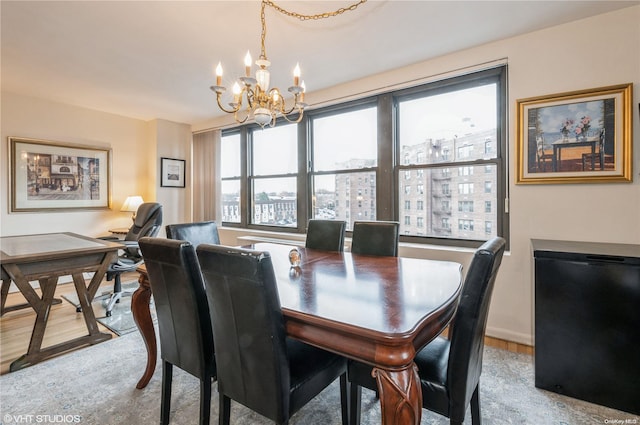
[131,273,158,389]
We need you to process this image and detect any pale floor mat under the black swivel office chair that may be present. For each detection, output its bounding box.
[62,281,156,336]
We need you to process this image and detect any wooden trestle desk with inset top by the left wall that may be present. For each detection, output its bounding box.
[0,232,124,372]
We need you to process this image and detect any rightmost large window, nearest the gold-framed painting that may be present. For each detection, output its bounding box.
[396,68,505,241]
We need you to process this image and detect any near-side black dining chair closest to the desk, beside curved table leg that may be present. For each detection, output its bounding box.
[140,237,216,425]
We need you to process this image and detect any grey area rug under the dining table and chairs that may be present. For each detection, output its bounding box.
[0,333,640,425]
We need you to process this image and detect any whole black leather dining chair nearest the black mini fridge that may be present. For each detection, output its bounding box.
[348,237,505,425]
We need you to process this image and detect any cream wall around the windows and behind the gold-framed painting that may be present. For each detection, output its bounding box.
[194,6,640,344]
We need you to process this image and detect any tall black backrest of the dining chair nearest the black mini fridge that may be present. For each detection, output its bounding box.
[447,237,506,421]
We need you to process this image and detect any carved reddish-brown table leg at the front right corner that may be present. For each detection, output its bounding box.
[372,363,422,425]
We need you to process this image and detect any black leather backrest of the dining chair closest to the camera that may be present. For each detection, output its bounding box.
[196,244,290,423]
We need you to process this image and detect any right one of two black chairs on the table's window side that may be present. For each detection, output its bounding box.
[351,221,400,257]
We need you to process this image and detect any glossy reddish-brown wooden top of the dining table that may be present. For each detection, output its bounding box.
[251,243,462,337]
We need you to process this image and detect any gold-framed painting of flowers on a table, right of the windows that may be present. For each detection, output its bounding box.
[516,84,632,184]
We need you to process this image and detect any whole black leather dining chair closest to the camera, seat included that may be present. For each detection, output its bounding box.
[196,244,348,425]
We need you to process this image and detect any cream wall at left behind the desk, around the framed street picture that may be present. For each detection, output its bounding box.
[0,92,191,236]
